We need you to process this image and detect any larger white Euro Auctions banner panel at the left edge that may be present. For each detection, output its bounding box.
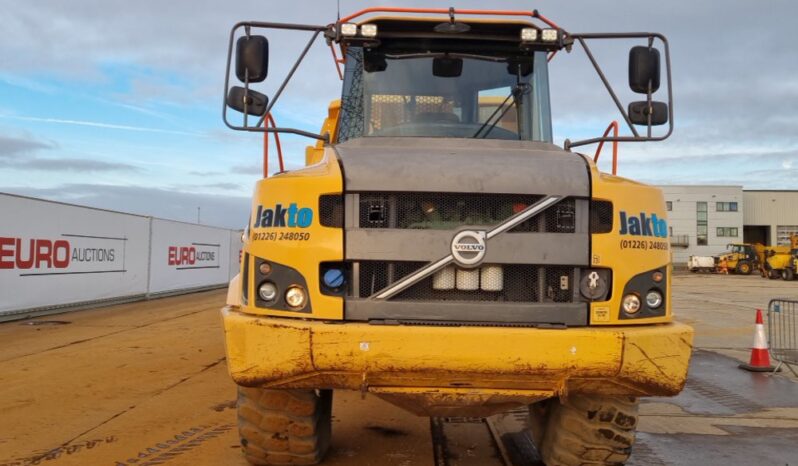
[0,194,150,314]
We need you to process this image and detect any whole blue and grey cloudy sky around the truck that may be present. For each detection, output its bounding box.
[0,0,798,228]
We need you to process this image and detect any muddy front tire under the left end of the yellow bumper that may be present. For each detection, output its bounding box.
[238,387,332,466]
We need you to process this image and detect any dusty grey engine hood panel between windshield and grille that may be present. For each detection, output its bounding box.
[333,137,590,197]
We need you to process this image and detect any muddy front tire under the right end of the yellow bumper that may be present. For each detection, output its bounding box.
[530,396,639,466]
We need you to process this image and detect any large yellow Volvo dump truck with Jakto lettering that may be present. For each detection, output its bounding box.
[217,8,693,466]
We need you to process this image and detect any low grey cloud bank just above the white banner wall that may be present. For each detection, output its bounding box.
[0,184,250,228]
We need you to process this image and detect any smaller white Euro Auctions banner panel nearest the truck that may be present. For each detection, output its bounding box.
[150,219,231,293]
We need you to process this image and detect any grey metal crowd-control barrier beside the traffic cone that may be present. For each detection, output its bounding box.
[768,298,798,377]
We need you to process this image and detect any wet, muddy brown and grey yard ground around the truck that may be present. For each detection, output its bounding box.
[0,275,798,466]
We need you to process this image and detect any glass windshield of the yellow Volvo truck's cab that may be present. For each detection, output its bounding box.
[338,47,552,142]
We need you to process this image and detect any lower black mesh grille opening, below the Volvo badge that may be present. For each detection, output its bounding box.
[350,261,576,303]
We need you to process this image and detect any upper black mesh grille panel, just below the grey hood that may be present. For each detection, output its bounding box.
[358,192,552,232]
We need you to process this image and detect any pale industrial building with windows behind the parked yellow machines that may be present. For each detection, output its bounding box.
[660,185,798,266]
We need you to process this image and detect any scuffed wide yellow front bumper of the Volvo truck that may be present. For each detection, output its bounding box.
[222,306,693,399]
